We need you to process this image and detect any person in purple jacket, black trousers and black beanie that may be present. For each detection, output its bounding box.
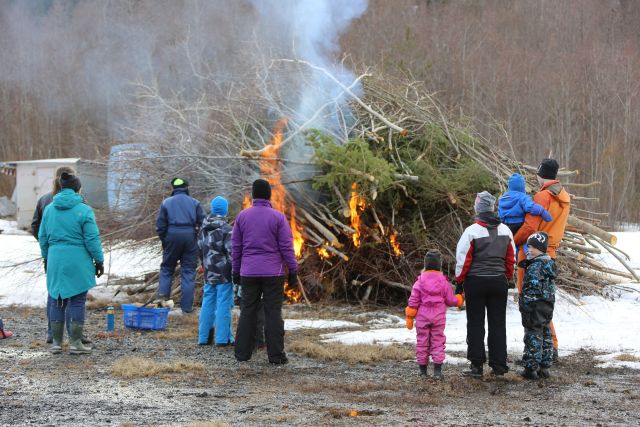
[231,179,298,364]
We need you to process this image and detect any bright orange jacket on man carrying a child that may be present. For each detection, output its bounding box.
[513,181,571,259]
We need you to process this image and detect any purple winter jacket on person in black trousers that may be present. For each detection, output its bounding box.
[231,199,298,277]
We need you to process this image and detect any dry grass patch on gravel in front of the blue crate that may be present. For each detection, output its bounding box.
[111,357,206,378]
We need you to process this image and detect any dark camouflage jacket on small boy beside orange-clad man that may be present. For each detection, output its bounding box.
[519,254,558,306]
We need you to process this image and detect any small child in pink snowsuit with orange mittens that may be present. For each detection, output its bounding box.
[405,249,464,379]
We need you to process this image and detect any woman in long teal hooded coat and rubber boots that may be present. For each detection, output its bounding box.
[38,173,104,354]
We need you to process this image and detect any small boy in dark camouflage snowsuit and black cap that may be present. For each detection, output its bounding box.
[519,231,557,380]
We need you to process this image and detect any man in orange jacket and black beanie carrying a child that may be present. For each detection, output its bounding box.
[513,159,571,360]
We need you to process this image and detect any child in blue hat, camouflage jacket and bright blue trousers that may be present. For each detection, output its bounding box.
[198,196,234,347]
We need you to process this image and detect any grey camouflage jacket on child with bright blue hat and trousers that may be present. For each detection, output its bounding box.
[198,214,232,285]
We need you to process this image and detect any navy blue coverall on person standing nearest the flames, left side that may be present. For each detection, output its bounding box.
[156,188,205,313]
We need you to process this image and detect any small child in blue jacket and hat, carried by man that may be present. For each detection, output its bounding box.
[498,173,553,235]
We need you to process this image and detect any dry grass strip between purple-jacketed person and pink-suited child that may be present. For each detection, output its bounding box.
[289,338,415,363]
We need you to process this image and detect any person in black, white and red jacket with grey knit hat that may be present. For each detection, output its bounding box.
[456,191,516,377]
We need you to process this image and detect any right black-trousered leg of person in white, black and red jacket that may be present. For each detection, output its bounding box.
[486,276,509,375]
